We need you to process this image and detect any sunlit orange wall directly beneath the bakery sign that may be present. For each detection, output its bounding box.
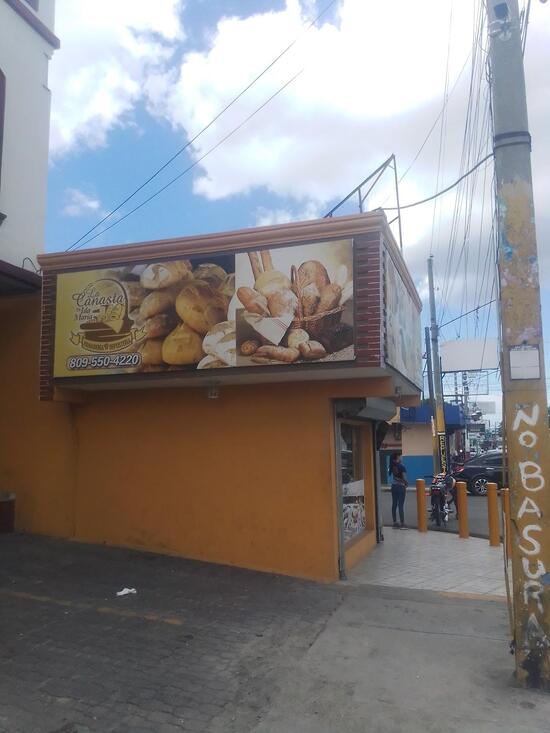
[75,382,390,580]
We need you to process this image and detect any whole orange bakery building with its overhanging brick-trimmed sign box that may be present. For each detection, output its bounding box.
[3,214,420,580]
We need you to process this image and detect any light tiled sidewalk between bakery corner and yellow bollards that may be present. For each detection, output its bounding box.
[344,527,506,599]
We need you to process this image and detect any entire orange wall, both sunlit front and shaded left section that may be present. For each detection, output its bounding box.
[0,297,396,580]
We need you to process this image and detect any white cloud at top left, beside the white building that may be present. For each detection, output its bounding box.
[49,0,183,157]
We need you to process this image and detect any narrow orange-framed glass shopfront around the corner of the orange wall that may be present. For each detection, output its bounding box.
[336,420,377,577]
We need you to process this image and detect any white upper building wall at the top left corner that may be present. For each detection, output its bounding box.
[0,0,59,267]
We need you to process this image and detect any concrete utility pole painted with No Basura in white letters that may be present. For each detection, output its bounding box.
[487,0,550,690]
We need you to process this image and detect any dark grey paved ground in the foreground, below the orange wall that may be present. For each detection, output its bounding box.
[0,532,550,733]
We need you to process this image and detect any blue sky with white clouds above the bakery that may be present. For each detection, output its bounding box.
[46,0,550,412]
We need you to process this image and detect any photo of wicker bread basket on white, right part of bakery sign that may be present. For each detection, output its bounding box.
[236,243,354,366]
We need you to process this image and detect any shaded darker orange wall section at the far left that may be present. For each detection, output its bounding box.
[0,295,76,537]
